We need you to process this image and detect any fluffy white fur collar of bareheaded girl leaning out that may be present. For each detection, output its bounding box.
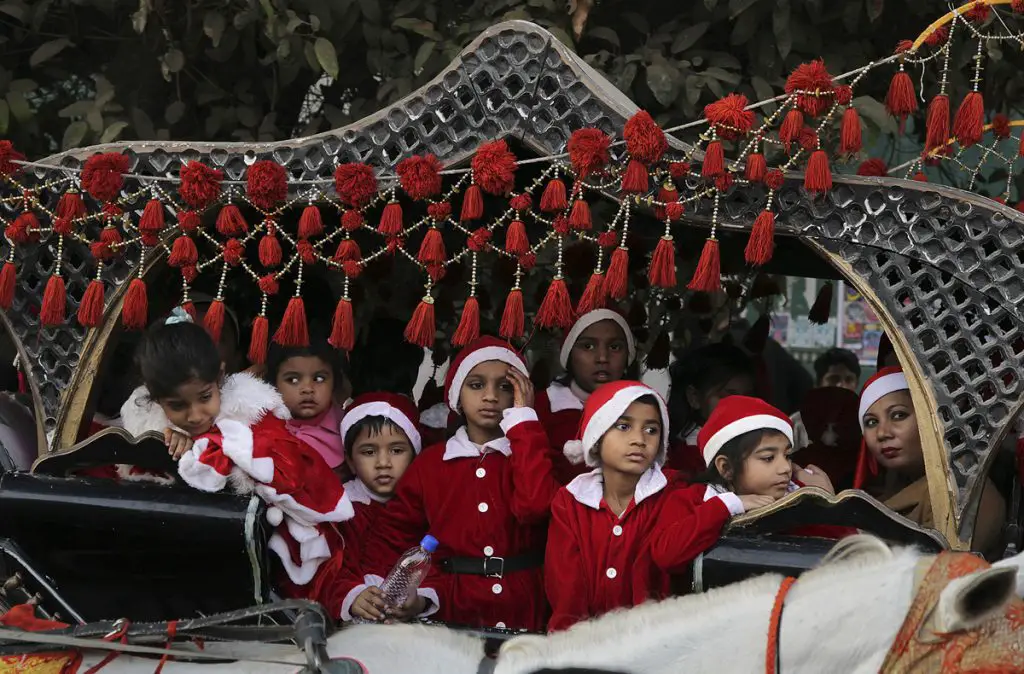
[121,372,291,435]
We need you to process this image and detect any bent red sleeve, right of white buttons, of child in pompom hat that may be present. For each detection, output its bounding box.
[650,485,729,573]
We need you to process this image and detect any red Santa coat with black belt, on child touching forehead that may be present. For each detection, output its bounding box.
[365,408,559,630]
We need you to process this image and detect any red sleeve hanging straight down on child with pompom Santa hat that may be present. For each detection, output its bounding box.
[544,490,589,632]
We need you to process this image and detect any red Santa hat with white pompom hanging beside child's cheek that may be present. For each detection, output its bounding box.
[563,380,669,467]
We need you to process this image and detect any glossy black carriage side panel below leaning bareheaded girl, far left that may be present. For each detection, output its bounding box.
[0,467,269,622]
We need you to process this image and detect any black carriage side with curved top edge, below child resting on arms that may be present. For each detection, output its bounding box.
[692,488,949,592]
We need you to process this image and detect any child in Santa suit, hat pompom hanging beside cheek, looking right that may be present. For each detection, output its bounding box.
[545,381,729,631]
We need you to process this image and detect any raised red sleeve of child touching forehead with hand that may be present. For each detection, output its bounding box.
[505,421,561,523]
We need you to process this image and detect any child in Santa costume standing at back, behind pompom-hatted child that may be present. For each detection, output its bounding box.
[537,309,637,485]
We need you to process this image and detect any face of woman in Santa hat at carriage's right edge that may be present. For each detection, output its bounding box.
[863,390,925,477]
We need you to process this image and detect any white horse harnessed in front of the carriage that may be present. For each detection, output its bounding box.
[54,536,1024,674]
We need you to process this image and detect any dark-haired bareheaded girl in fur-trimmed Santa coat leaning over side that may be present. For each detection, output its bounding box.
[121,317,353,598]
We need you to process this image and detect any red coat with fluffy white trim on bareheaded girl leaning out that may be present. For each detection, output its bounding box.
[121,373,353,598]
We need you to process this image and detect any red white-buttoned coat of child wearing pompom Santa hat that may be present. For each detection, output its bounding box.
[545,468,738,631]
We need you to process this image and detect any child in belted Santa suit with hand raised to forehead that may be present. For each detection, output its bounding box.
[365,337,559,630]
